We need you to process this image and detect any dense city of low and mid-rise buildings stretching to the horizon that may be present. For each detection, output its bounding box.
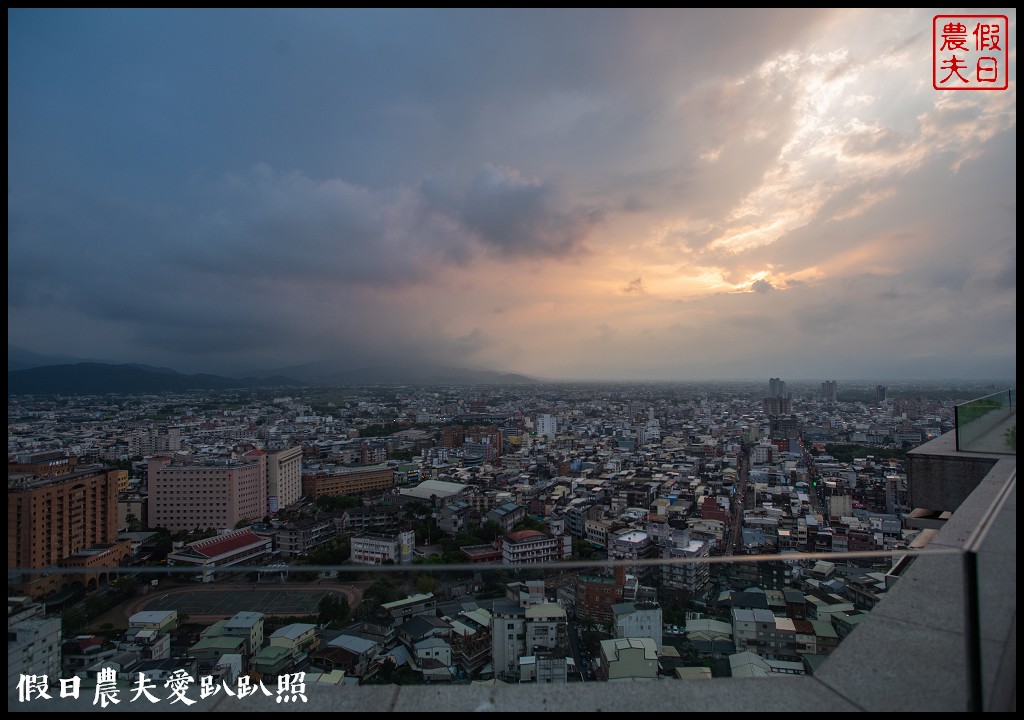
[8,378,1016,708]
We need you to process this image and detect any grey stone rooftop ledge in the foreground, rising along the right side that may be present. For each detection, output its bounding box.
[8,407,1016,713]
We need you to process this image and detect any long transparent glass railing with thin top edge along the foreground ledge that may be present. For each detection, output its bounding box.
[8,475,1016,711]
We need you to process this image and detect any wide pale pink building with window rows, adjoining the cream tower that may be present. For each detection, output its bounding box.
[148,450,267,533]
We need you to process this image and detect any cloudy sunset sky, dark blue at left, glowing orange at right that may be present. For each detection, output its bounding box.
[7,8,1017,383]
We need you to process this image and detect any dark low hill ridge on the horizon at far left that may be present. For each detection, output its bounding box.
[7,363,302,395]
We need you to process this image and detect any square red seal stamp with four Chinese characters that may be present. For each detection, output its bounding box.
[932,15,1010,90]
